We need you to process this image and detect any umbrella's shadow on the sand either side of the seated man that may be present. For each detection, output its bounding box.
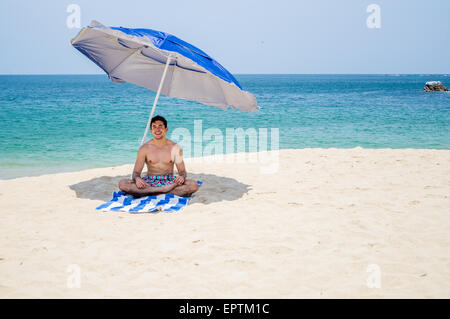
[69,174,251,204]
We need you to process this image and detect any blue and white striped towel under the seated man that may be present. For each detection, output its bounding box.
[96,181,203,213]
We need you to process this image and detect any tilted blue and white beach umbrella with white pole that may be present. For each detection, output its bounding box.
[71,21,258,144]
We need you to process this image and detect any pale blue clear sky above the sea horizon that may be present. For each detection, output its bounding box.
[0,0,450,74]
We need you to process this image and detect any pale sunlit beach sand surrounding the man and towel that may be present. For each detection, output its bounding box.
[0,148,450,298]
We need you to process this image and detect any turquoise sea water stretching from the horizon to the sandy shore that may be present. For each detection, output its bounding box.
[0,75,450,179]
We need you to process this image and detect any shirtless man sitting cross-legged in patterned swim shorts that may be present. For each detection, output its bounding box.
[119,115,198,197]
